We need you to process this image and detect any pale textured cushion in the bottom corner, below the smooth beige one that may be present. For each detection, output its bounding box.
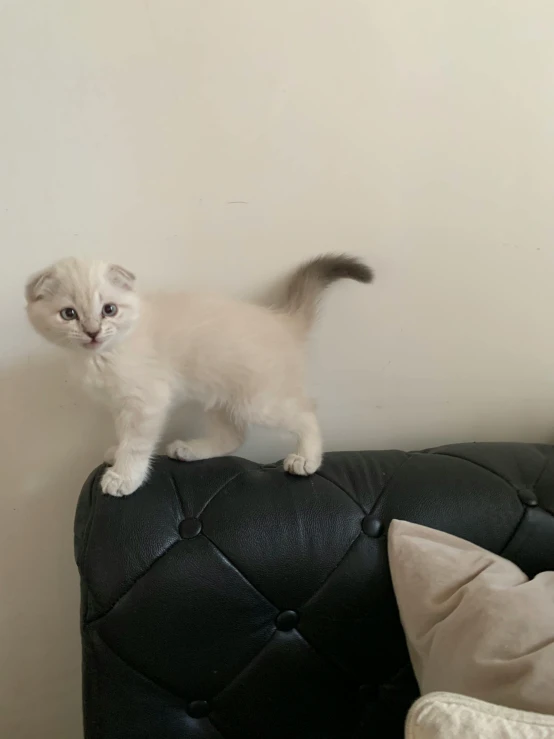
[406,693,554,739]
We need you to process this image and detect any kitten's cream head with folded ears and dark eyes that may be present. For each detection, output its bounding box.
[25,258,140,352]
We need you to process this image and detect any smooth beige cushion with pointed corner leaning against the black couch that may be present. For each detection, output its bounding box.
[388,521,554,714]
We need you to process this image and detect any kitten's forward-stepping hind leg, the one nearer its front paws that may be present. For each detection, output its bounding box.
[167,408,246,462]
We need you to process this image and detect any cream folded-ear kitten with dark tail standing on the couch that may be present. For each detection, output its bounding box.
[26,255,373,496]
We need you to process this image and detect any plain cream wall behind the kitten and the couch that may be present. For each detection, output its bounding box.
[0,0,554,739]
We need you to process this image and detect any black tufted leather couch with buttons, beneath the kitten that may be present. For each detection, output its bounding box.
[75,444,554,739]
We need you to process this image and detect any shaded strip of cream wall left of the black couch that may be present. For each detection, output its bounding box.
[0,357,113,739]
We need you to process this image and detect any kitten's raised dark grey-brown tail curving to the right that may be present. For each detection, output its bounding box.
[275,254,373,332]
